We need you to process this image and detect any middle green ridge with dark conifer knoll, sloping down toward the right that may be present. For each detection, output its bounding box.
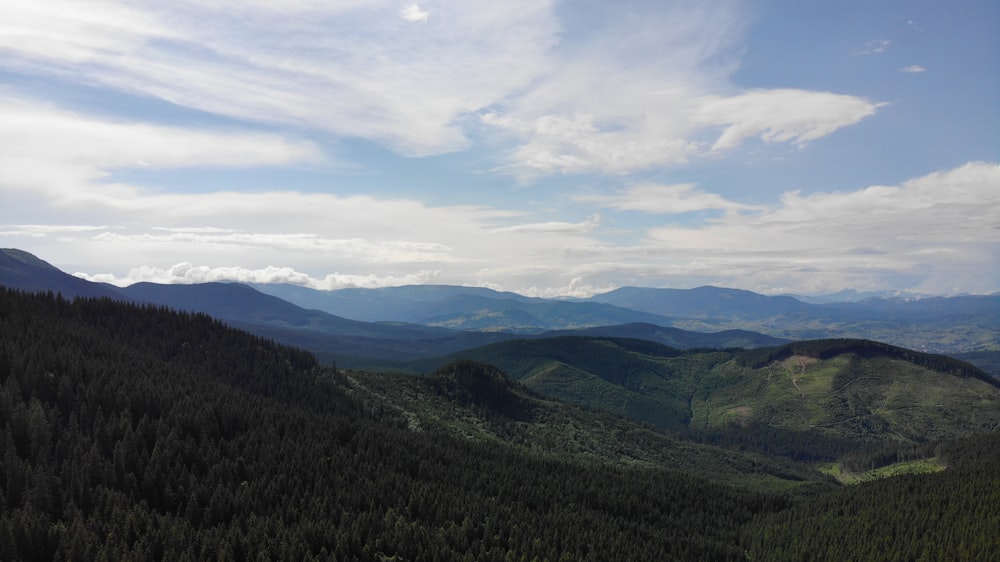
[345,361,829,490]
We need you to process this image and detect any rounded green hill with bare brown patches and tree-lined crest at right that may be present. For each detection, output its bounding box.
[692,340,1000,443]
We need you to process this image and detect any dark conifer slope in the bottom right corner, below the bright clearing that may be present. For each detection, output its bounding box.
[741,433,1000,562]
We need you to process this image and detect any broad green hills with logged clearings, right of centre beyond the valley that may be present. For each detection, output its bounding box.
[436,338,1000,460]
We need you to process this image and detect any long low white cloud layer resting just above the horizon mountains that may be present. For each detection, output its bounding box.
[37,162,1000,296]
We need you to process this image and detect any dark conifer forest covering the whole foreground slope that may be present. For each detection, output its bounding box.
[0,290,1000,561]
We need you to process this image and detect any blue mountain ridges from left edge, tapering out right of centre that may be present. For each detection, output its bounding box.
[0,250,787,368]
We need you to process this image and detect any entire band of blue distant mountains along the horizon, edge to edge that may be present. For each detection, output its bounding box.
[0,250,1000,375]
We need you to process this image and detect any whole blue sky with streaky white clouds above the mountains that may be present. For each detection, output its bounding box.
[0,0,1000,297]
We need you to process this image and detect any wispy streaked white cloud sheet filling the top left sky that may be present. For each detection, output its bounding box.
[0,0,558,155]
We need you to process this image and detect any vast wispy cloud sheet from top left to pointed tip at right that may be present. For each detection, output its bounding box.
[0,0,884,173]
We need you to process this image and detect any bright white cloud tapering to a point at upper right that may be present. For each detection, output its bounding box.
[481,83,881,175]
